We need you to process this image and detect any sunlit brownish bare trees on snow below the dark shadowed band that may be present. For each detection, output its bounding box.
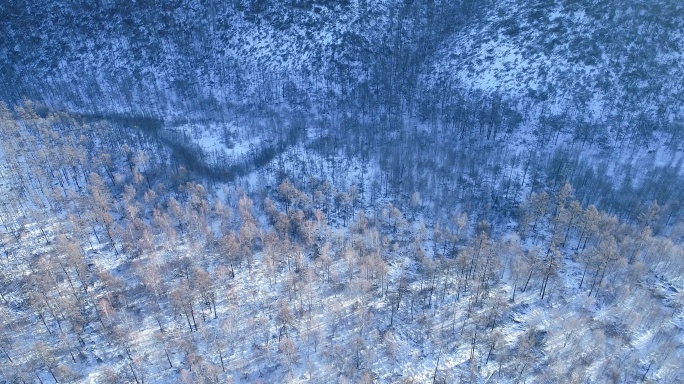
[0,103,684,384]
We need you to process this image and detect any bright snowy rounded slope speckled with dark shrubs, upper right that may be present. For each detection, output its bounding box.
[425,0,684,130]
